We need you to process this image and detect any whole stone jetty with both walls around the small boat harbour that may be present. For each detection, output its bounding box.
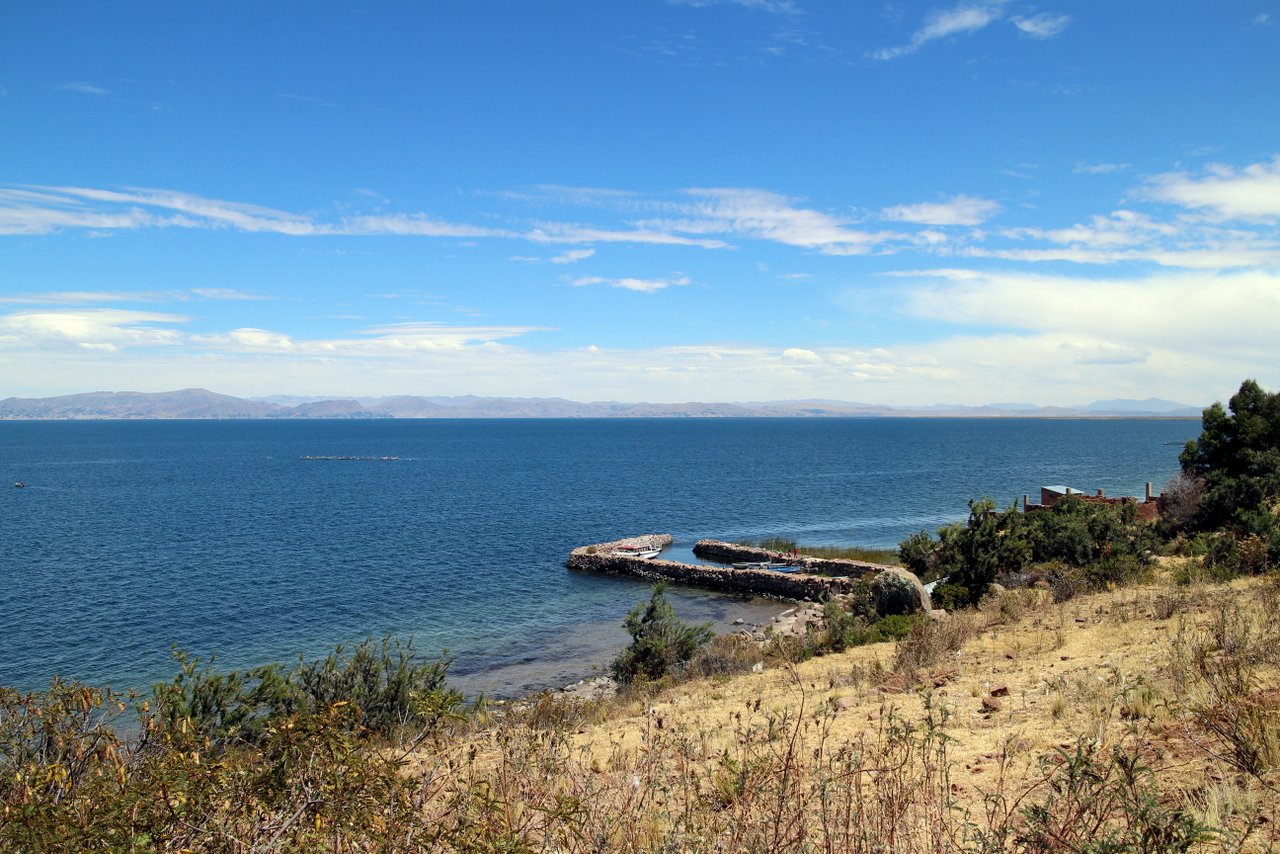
[564,534,886,602]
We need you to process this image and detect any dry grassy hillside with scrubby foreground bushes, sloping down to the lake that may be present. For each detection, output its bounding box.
[0,558,1280,851]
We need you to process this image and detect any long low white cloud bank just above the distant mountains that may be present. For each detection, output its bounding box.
[0,297,1254,405]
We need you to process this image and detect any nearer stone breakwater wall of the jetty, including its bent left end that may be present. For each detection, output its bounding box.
[564,534,860,602]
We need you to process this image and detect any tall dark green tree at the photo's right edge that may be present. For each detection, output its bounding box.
[1179,379,1280,538]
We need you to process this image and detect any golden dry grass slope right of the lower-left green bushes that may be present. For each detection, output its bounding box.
[412,563,1280,851]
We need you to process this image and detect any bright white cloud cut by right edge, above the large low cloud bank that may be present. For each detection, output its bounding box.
[1144,155,1280,219]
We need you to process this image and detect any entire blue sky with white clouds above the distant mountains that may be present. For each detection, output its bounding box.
[0,0,1280,405]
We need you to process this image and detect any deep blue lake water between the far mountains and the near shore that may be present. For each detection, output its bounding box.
[0,419,1199,695]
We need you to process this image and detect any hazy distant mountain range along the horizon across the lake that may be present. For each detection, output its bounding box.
[0,388,1201,420]
